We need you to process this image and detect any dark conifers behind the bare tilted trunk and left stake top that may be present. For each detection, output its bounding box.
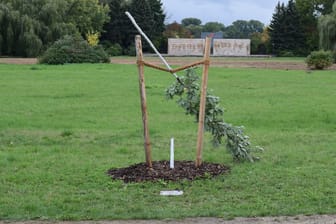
[101,0,166,54]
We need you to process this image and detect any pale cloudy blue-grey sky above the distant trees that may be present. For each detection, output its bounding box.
[161,0,288,26]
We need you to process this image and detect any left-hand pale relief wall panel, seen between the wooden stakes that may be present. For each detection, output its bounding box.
[168,38,205,56]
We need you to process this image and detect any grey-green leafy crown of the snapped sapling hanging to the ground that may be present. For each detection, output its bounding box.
[166,69,258,162]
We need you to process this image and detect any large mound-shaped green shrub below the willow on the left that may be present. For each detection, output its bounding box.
[39,36,110,64]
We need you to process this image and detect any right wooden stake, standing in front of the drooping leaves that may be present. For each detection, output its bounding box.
[195,37,211,167]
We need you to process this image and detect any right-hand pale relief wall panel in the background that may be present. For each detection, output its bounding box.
[213,39,251,56]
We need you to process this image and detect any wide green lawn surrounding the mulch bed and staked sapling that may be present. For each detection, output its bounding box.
[0,64,336,220]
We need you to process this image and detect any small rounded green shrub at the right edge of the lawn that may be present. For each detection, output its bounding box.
[306,50,333,70]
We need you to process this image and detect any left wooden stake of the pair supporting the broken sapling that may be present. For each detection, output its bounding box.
[135,35,152,168]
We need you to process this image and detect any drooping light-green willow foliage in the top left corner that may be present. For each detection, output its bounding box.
[0,0,109,57]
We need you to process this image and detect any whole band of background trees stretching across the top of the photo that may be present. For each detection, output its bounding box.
[0,0,336,57]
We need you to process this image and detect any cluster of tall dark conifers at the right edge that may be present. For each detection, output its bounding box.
[269,0,336,56]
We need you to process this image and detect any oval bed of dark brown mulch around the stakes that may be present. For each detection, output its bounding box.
[107,161,230,183]
